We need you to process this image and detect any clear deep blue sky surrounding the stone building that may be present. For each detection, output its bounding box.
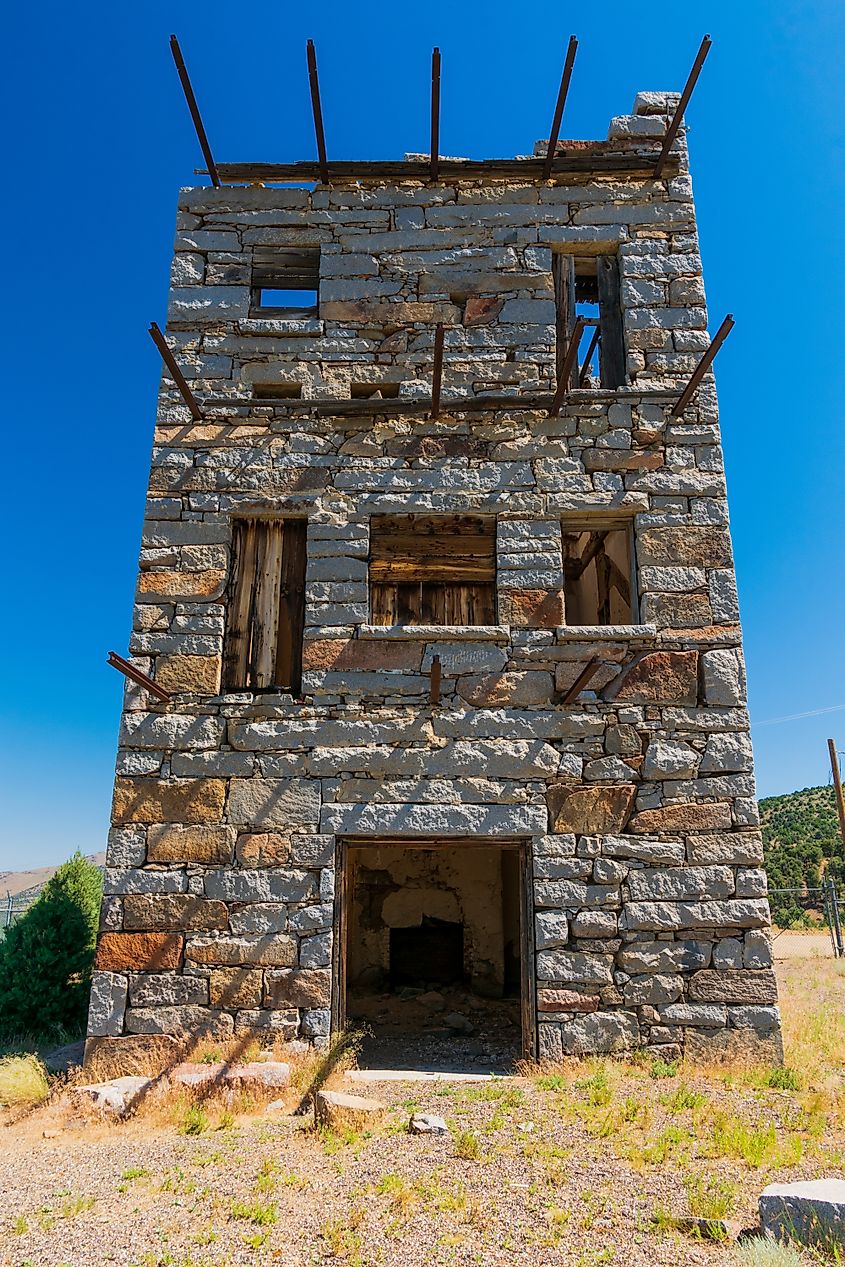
[0,0,845,869]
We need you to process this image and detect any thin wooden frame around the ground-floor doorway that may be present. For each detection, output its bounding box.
[332,836,537,1060]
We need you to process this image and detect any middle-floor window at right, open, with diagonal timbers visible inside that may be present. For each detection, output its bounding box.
[562,518,637,625]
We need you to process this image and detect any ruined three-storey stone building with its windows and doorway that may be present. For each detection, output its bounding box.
[89,81,779,1059]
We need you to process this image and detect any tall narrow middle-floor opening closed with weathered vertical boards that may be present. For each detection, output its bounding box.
[223,519,307,696]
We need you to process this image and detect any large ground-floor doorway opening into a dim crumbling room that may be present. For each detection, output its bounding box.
[332,837,536,1073]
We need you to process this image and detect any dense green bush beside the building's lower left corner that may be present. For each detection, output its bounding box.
[0,853,103,1039]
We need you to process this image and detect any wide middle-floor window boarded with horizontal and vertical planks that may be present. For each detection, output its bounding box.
[370,514,495,625]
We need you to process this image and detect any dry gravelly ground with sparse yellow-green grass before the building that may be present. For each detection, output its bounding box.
[0,958,845,1267]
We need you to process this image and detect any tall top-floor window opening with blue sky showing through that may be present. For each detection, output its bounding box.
[552,253,628,388]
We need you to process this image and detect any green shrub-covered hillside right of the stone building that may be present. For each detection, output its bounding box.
[760,787,845,927]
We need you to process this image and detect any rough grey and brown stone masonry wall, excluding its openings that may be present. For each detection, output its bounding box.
[82,86,779,1059]
